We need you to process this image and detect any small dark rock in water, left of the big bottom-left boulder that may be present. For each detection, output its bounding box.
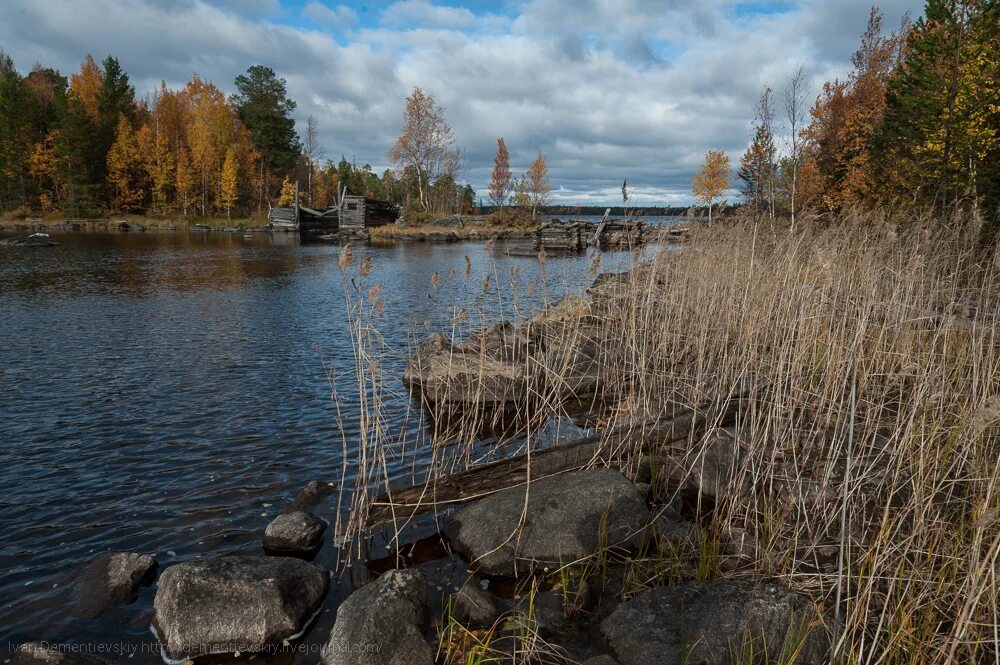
[74,552,156,619]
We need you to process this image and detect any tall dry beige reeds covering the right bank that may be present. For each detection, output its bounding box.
[334,209,1000,663]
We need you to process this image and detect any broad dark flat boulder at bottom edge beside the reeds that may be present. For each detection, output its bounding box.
[601,580,832,665]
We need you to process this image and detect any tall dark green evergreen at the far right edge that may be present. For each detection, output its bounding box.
[873,0,1000,216]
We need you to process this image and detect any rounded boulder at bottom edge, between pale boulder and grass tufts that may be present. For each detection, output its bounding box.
[322,569,434,665]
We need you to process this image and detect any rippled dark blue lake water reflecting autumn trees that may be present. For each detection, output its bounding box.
[0,233,629,662]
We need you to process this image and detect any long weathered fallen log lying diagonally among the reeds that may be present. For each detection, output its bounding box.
[365,398,746,528]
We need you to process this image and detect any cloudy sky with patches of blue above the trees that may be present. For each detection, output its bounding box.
[0,0,922,206]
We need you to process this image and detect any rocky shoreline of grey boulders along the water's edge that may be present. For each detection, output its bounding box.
[13,266,838,665]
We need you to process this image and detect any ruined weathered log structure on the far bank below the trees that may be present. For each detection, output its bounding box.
[267,183,399,235]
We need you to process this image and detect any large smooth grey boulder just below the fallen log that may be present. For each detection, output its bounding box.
[445,469,649,576]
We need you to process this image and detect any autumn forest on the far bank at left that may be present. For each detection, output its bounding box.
[0,51,474,216]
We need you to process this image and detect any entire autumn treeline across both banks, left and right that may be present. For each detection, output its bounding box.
[0,0,1000,226]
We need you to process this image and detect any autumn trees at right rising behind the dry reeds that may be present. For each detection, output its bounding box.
[693,0,1000,229]
